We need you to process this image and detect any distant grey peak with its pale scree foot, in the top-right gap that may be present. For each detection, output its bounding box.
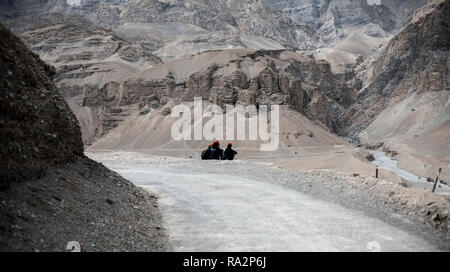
[266,0,427,71]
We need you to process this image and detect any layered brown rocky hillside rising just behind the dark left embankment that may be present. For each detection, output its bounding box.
[3,13,162,144]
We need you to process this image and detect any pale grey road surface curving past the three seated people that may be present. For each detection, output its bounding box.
[91,153,437,251]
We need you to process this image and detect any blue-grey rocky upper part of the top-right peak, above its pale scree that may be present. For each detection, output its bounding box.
[266,0,426,44]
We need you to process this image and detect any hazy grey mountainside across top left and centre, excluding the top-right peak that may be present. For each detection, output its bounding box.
[3,0,320,60]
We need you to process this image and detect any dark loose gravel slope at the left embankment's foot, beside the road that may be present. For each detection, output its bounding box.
[0,157,167,252]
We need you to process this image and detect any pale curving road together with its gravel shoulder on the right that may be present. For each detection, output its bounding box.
[88,152,450,251]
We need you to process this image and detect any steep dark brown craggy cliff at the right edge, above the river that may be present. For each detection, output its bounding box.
[346,1,450,137]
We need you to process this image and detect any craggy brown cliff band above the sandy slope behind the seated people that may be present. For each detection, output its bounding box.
[60,49,353,142]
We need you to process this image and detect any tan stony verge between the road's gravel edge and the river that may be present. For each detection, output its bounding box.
[254,148,450,237]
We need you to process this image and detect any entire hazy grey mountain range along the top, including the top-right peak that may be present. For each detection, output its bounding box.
[0,0,436,63]
